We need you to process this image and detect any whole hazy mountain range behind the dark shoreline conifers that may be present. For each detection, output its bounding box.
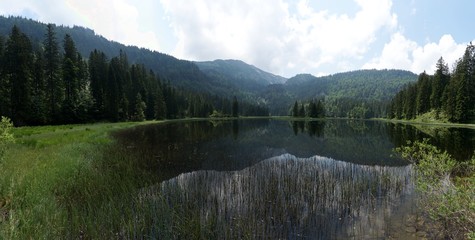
[0,16,417,116]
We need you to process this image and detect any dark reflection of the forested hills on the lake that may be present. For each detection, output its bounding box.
[114,119,475,183]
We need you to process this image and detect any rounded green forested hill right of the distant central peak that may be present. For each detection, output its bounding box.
[262,70,417,118]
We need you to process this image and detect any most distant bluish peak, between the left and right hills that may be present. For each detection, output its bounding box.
[195,60,287,91]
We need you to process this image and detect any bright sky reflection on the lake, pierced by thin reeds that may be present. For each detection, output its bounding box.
[143,154,413,239]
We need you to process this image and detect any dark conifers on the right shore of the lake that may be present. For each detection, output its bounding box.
[387,43,475,123]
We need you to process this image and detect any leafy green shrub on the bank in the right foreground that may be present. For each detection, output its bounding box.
[397,140,475,239]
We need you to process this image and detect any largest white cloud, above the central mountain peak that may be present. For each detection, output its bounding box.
[161,0,397,76]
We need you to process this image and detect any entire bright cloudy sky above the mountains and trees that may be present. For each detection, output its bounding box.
[0,0,475,77]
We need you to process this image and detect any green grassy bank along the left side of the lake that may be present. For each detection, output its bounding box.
[0,123,162,239]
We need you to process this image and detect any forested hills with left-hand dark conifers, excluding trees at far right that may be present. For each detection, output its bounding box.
[0,16,424,124]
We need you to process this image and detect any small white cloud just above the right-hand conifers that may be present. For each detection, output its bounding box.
[363,32,466,74]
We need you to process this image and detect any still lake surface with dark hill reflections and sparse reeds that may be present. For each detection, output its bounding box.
[114,119,475,239]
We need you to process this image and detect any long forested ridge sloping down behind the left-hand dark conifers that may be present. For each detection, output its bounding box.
[0,16,229,96]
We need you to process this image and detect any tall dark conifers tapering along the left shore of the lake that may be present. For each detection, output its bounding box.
[0,24,269,126]
